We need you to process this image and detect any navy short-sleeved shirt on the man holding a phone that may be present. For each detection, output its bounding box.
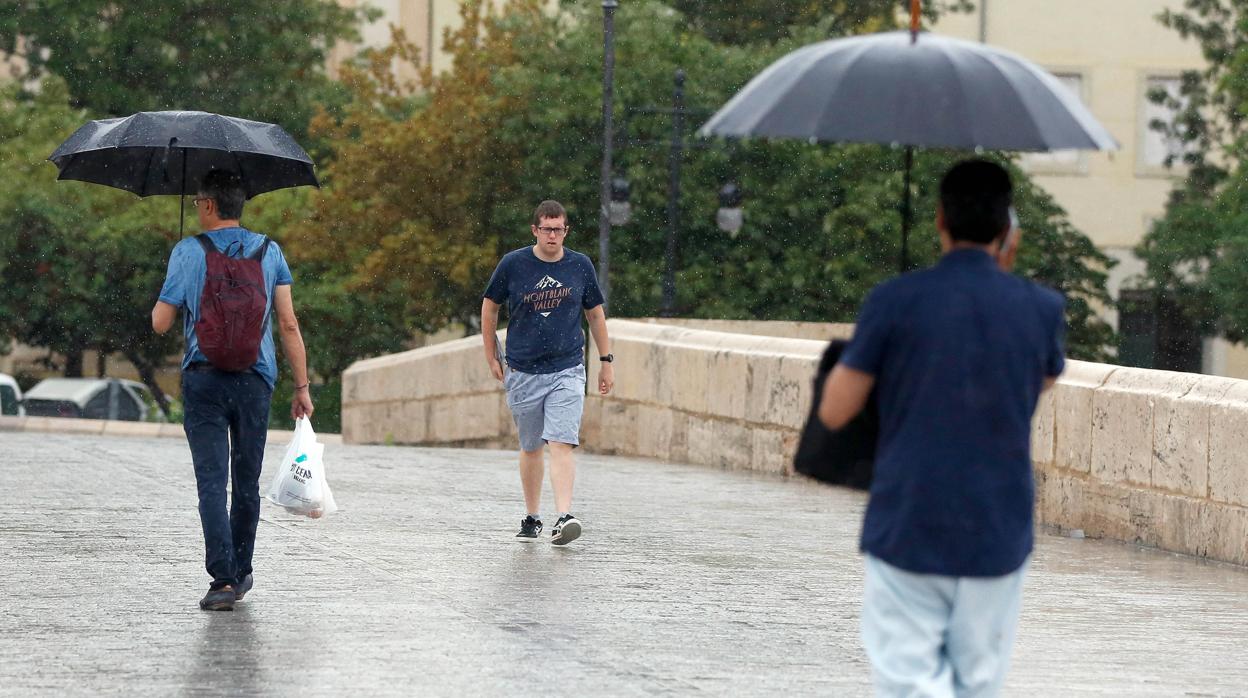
[841,250,1066,577]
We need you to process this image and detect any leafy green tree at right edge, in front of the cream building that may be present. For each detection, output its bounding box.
[1137,0,1248,341]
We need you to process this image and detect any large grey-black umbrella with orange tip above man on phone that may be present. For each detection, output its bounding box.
[699,2,1118,271]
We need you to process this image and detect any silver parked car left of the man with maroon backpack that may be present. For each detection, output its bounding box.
[21,378,166,422]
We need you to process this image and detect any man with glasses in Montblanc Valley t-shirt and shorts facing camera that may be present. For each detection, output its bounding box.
[480,201,615,546]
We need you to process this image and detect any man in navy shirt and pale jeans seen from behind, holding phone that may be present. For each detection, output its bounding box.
[819,160,1065,697]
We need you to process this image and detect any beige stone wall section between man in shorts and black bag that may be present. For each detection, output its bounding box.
[583,320,825,473]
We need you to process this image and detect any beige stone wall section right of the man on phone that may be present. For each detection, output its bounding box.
[1032,361,1248,564]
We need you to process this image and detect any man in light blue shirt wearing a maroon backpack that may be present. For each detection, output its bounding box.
[152,170,312,611]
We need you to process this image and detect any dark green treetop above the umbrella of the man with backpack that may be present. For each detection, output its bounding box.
[0,0,364,139]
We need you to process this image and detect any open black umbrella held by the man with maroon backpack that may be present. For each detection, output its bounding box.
[49,111,319,235]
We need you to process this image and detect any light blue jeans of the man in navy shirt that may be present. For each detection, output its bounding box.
[862,554,1027,698]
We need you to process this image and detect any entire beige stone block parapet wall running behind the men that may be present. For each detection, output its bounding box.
[342,320,1248,564]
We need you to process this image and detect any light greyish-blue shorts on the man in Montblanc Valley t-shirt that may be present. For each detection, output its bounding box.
[503,366,585,451]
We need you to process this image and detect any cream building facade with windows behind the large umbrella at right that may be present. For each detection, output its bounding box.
[934,0,1248,378]
